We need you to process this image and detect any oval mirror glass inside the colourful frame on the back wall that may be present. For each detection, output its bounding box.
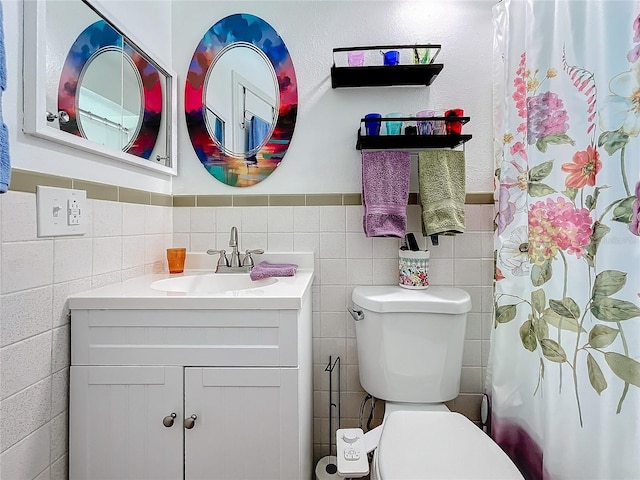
[204,42,280,157]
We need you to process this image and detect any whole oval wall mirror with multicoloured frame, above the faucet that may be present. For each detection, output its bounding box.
[185,13,298,187]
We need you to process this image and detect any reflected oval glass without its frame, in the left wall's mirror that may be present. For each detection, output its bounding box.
[77,48,142,150]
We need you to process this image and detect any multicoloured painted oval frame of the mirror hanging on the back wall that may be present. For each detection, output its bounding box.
[185,13,298,187]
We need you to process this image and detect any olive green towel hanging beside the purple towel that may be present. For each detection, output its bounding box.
[418,150,465,236]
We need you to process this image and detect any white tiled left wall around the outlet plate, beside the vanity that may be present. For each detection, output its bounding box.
[0,174,173,480]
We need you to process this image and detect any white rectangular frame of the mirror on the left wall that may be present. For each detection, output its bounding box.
[23,0,178,175]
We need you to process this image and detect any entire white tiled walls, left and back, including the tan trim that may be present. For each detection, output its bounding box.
[0,171,493,480]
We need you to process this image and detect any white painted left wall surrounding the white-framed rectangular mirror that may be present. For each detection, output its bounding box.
[2,0,171,193]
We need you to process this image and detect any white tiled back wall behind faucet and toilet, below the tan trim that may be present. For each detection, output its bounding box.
[173,196,493,461]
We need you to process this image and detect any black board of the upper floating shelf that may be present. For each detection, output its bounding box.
[331,63,444,88]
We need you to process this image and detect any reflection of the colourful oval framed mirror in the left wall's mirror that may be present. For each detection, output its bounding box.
[58,20,164,159]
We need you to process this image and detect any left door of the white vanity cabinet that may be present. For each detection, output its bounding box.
[69,366,183,480]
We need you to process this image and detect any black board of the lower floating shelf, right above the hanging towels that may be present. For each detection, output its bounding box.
[356,131,471,150]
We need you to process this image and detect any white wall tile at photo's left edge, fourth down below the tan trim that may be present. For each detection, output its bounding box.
[0,331,51,400]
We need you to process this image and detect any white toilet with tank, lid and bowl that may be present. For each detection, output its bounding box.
[351,286,523,480]
